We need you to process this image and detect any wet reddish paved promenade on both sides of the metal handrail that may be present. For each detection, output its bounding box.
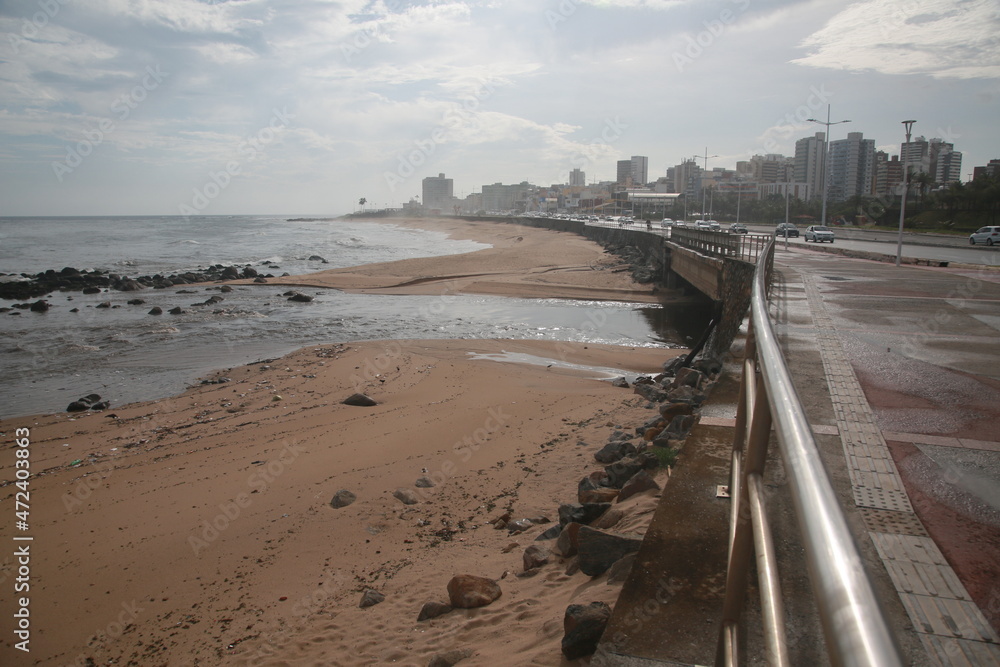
[593,249,1000,666]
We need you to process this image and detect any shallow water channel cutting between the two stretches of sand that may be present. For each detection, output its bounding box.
[0,285,712,417]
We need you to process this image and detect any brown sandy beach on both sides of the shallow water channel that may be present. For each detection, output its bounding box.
[0,221,680,666]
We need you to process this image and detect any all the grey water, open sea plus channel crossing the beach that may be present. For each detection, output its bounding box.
[0,216,709,417]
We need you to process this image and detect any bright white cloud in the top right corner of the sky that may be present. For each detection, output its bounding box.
[793,0,1000,79]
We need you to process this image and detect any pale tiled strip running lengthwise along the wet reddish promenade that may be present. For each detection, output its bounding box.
[777,248,1000,665]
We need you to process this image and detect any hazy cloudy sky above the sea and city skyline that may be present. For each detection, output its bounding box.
[0,0,1000,216]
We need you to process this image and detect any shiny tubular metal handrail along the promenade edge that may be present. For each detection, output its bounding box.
[716,240,903,667]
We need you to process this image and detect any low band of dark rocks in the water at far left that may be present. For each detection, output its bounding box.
[0,258,304,300]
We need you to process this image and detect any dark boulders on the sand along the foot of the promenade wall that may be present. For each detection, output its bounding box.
[330,357,722,665]
